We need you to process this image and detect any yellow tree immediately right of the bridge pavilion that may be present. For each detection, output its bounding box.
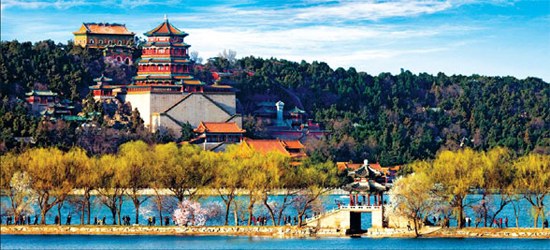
[387,168,441,237]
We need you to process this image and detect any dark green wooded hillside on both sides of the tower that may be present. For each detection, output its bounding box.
[0,41,550,165]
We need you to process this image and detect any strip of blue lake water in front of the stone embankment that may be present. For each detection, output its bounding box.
[0,235,550,250]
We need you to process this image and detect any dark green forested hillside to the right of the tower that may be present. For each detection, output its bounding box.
[201,57,550,165]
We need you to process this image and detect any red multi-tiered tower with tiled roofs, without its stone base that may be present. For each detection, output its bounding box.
[133,18,204,93]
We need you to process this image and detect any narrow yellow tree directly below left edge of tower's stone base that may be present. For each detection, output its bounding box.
[118,141,154,224]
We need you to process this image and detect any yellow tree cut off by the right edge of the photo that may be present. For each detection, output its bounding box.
[514,153,550,227]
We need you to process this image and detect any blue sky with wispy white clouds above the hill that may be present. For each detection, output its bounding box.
[1,0,550,82]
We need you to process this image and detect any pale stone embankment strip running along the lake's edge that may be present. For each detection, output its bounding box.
[0,225,550,239]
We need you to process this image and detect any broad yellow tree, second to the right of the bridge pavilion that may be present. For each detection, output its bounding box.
[420,148,483,228]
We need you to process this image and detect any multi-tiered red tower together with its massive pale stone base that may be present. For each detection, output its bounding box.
[117,18,242,135]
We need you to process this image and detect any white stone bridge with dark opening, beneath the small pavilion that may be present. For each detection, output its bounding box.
[304,206,384,234]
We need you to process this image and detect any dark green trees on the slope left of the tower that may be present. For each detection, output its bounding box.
[0,40,147,154]
